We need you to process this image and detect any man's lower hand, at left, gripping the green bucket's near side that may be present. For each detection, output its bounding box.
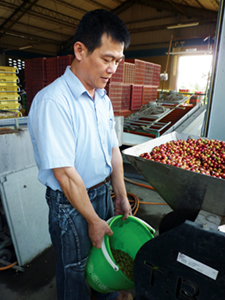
[88,219,113,249]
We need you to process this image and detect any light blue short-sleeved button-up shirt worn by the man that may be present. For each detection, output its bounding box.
[28,67,118,190]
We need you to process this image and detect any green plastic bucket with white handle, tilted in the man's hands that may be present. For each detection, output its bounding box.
[85,215,155,293]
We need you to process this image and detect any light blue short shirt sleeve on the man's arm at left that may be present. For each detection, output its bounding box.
[30,99,75,170]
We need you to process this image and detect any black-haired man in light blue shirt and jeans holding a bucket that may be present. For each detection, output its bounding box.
[28,10,132,300]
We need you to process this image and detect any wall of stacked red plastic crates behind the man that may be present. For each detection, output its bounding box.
[25,55,161,113]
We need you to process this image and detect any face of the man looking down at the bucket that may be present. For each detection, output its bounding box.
[79,34,124,91]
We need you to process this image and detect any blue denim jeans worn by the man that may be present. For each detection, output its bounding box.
[46,182,118,300]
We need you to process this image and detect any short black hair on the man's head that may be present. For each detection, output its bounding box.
[74,9,130,54]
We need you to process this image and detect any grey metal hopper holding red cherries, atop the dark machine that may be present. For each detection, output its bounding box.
[123,131,225,217]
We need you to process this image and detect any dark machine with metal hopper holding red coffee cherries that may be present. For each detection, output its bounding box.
[123,132,225,300]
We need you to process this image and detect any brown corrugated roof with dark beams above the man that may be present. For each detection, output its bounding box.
[0,0,219,56]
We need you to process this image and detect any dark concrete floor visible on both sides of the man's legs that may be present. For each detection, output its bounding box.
[0,163,171,300]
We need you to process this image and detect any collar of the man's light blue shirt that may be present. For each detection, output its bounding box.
[64,66,106,99]
